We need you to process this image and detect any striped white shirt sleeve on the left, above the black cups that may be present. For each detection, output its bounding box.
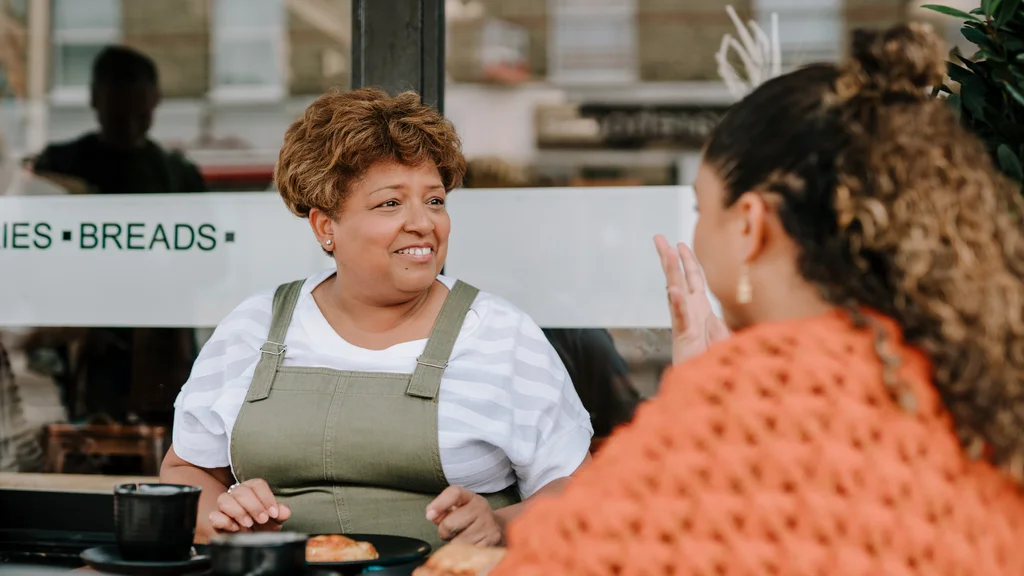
[172,293,272,468]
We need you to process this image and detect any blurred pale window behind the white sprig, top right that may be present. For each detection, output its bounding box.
[754,0,846,68]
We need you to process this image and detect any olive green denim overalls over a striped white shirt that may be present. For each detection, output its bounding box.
[230,281,520,549]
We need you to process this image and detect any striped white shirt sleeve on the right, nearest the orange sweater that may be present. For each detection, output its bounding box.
[506,314,594,498]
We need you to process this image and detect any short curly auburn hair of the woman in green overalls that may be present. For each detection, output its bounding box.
[273,88,466,218]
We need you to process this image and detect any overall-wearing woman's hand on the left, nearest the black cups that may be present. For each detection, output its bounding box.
[210,479,292,532]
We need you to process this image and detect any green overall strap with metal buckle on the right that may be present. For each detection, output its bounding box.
[406,280,479,400]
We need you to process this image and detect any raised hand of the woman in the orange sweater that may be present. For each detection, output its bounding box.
[654,235,729,364]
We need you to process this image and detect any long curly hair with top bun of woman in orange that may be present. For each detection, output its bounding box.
[705,25,1024,480]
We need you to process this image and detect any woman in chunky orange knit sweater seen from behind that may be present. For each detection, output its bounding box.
[481,25,1024,576]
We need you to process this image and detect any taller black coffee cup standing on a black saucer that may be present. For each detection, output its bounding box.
[114,484,201,562]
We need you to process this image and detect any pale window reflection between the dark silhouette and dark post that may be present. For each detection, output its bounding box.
[211,0,288,100]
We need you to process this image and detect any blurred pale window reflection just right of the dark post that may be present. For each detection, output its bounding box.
[548,0,639,84]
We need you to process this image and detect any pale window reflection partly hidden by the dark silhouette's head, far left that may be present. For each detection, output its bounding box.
[51,0,122,102]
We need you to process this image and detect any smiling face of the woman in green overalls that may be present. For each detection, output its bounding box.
[330,162,452,298]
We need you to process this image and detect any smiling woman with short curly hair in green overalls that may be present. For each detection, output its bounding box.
[161,89,592,545]
